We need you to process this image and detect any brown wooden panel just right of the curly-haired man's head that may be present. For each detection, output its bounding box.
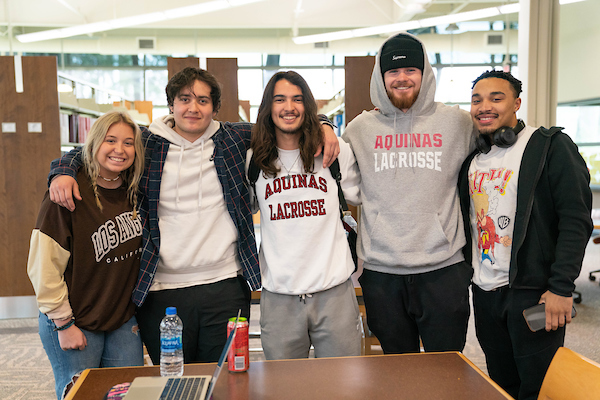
[206,58,240,122]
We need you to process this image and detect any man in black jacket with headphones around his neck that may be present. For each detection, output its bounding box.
[459,71,593,399]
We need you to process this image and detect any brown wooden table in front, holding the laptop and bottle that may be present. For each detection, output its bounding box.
[67,352,511,400]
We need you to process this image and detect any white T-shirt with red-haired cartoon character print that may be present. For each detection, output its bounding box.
[469,127,535,291]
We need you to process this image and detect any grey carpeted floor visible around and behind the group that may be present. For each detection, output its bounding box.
[0,242,600,400]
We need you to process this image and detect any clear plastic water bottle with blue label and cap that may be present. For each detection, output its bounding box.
[160,307,183,376]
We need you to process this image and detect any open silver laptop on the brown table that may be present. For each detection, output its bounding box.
[123,310,242,400]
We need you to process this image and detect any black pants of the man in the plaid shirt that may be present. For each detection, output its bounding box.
[137,276,250,365]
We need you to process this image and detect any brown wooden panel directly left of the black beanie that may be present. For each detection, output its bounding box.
[344,56,375,125]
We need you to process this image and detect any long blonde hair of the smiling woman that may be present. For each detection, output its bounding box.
[82,111,145,219]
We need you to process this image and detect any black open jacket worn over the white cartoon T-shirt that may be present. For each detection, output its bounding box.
[458,127,593,297]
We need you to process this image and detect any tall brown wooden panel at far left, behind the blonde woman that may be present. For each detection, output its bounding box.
[0,56,60,296]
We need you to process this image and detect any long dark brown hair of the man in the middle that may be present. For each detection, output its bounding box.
[250,71,322,177]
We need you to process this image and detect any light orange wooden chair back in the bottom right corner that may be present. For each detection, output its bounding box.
[538,347,600,400]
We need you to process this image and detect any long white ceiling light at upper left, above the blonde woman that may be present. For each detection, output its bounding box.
[16,0,265,43]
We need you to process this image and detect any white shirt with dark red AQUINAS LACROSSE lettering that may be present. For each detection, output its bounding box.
[248,140,360,295]
